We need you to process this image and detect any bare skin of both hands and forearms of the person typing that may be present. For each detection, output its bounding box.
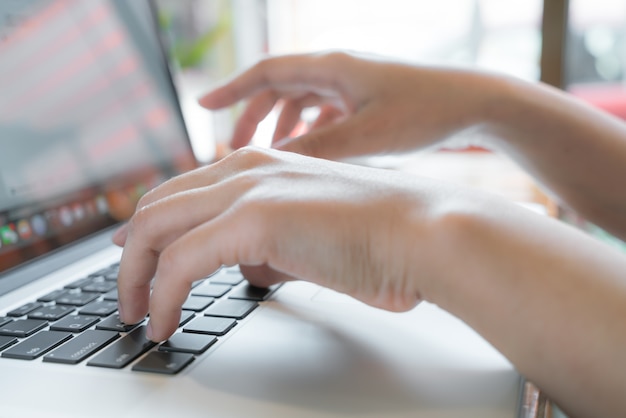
[114,53,626,417]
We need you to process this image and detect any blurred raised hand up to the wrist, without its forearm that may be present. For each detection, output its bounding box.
[200,52,493,159]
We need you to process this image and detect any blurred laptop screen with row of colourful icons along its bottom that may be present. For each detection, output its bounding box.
[0,0,195,272]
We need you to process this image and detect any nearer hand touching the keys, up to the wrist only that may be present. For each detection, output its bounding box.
[115,148,442,340]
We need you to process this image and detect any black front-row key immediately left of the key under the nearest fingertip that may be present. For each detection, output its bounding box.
[43,330,120,364]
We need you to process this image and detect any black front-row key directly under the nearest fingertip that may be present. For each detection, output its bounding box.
[87,326,156,369]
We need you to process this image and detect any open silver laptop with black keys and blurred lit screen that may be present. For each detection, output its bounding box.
[0,0,523,418]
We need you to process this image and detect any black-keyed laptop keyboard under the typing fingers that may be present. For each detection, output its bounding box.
[0,263,279,375]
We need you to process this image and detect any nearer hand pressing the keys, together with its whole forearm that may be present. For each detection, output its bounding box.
[115,148,626,416]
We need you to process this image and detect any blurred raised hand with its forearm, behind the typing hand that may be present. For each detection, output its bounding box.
[200,53,626,239]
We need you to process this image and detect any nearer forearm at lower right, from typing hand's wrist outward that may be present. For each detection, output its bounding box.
[423,199,626,417]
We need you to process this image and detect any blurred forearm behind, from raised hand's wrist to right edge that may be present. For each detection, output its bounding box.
[486,74,626,239]
